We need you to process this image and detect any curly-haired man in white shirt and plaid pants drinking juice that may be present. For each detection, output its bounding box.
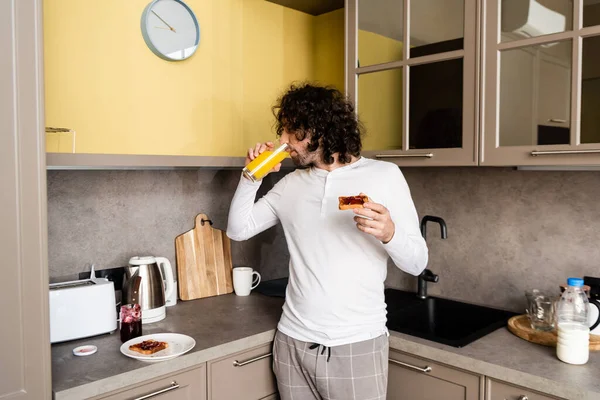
[227,84,428,400]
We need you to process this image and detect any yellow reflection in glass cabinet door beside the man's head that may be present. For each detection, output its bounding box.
[357,30,403,150]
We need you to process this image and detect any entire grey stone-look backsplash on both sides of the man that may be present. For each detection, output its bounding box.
[48,168,600,311]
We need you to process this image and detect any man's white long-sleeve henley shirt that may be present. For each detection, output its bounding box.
[227,157,428,346]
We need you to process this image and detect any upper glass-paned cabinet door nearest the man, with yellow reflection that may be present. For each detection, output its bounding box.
[346,0,478,166]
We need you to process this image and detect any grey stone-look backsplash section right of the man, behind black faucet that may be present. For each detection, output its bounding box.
[387,168,600,312]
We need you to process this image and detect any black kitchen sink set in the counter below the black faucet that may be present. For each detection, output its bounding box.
[385,289,517,347]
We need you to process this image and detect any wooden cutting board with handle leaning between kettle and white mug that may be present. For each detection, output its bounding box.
[175,214,233,300]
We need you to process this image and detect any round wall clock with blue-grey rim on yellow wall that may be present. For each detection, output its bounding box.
[141,0,200,61]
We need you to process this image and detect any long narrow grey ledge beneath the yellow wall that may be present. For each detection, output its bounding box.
[46,153,293,170]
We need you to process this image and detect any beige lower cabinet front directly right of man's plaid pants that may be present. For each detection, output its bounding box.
[387,351,483,400]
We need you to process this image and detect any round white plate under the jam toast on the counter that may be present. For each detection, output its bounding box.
[121,333,196,362]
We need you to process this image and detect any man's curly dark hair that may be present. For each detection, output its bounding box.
[272,83,363,165]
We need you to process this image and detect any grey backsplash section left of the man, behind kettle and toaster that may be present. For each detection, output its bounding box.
[48,169,289,281]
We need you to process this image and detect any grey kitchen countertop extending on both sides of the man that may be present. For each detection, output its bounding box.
[52,294,600,400]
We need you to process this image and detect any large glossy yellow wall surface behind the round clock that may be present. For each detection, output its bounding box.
[44,0,343,155]
